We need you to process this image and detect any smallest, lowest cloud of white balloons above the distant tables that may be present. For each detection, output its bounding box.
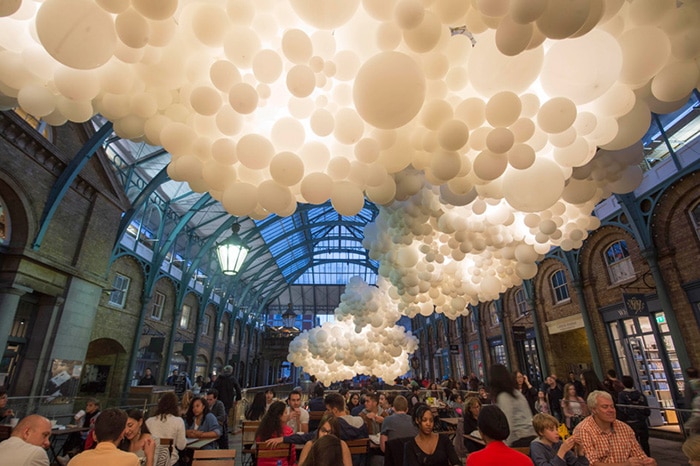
[287,277,418,384]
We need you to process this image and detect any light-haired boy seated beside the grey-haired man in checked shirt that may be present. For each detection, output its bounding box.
[530,413,589,466]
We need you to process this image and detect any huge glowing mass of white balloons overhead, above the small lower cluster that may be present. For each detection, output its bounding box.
[0,0,700,378]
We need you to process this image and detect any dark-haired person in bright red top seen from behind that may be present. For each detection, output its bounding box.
[467,405,533,466]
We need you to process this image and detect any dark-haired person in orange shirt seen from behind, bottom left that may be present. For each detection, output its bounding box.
[70,408,156,466]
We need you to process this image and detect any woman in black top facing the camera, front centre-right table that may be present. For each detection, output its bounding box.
[403,403,460,466]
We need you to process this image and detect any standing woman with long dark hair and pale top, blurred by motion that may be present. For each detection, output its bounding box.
[489,364,537,447]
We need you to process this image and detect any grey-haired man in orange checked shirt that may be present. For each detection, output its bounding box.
[574,390,656,466]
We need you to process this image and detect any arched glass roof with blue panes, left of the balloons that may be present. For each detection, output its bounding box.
[100,116,378,309]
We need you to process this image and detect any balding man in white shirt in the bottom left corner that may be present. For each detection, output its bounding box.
[0,414,51,466]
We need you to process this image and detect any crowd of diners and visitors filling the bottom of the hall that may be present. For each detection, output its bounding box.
[0,364,700,466]
